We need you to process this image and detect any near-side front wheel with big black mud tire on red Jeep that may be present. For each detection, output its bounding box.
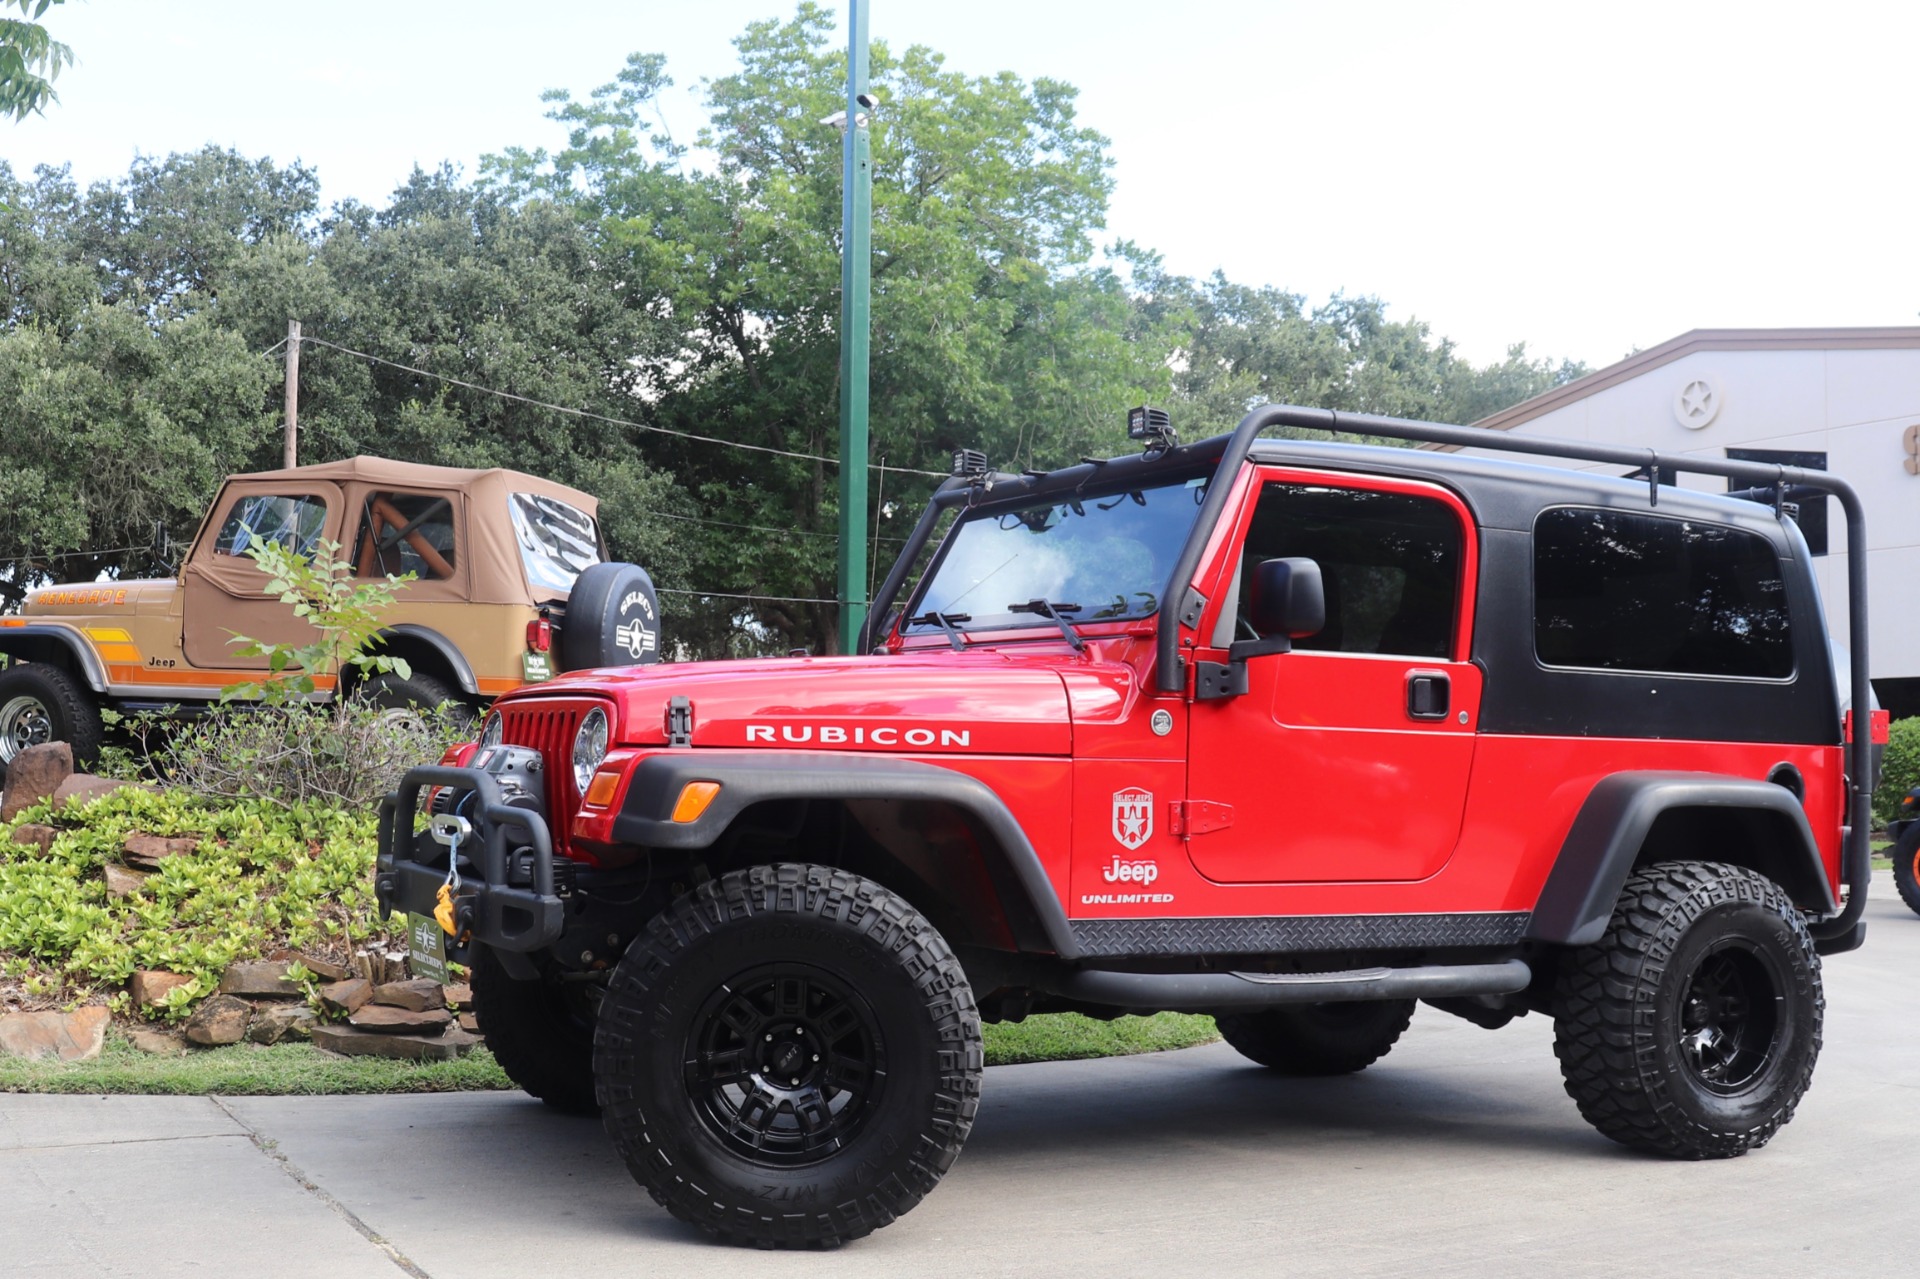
[593,864,983,1248]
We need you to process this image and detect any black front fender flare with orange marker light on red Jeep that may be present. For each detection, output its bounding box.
[612,751,1081,962]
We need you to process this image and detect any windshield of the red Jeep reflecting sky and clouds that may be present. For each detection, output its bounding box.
[902,478,1206,634]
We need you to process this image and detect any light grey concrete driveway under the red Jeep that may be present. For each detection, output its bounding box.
[0,878,1920,1279]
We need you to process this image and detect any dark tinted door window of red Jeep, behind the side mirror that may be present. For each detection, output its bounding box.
[1238,484,1461,661]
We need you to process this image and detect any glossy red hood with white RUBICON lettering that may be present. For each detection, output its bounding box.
[526,653,1073,755]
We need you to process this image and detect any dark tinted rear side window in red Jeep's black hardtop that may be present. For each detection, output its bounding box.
[1534,509,1793,680]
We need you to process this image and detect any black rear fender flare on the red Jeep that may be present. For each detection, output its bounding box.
[1526,772,1839,947]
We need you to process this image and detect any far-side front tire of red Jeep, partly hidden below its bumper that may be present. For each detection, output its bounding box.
[472,947,599,1114]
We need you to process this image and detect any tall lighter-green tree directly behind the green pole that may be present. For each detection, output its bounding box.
[486,4,1169,649]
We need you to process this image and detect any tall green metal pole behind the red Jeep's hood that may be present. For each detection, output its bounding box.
[839,0,874,653]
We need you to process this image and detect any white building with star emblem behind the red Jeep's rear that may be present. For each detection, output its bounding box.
[1476,328,1920,716]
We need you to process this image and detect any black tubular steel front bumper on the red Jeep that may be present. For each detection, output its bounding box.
[374,764,566,958]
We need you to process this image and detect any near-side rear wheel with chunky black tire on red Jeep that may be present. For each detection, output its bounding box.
[1553,862,1826,1160]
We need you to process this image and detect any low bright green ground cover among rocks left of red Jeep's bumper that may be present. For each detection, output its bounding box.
[0,787,386,1020]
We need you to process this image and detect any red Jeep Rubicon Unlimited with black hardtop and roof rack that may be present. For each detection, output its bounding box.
[376,407,1874,1246]
